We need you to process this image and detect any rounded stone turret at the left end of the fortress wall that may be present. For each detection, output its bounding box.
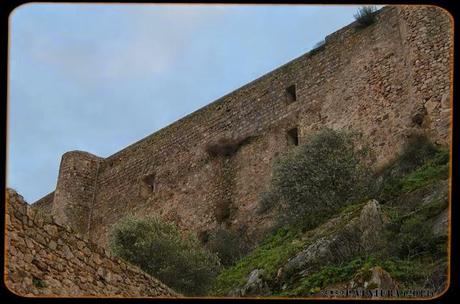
[52,151,101,234]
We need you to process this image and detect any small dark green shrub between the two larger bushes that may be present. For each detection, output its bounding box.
[206,228,248,266]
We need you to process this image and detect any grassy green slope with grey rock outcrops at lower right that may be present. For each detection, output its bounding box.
[210,146,449,297]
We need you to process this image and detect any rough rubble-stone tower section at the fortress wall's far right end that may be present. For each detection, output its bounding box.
[400,8,453,145]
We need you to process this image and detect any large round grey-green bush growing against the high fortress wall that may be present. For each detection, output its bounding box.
[272,129,372,228]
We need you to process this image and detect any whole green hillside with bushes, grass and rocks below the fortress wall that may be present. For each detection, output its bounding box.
[110,129,449,297]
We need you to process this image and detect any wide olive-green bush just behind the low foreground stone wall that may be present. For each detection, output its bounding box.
[110,216,220,295]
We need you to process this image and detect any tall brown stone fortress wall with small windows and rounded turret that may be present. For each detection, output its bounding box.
[33,6,452,245]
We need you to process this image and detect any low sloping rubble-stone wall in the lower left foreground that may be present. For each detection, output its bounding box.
[5,189,177,297]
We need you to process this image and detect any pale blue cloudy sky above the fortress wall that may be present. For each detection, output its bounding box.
[7,4,372,203]
